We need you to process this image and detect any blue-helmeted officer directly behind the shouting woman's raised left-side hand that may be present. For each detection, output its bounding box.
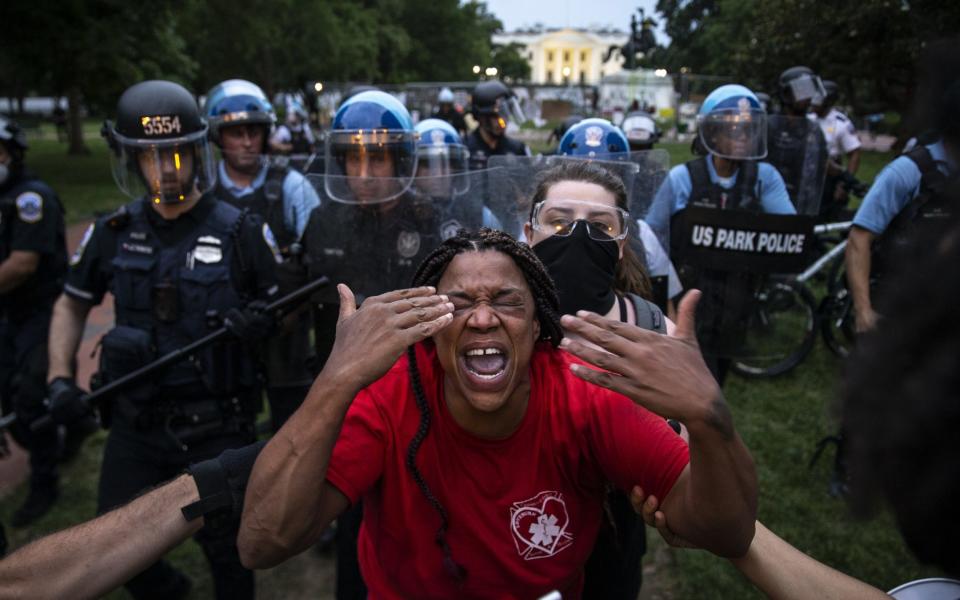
[303,90,422,598]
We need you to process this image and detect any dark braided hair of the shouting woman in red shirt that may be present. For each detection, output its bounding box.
[406,227,563,582]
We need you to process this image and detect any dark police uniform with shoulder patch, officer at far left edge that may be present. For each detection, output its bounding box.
[0,174,67,521]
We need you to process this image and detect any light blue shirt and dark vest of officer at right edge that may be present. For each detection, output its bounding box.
[853,142,960,276]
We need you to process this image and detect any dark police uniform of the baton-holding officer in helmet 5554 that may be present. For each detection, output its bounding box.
[64,194,280,598]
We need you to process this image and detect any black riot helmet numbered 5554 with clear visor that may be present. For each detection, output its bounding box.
[101,80,216,204]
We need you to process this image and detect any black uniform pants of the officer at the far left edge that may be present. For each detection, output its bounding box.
[0,307,59,489]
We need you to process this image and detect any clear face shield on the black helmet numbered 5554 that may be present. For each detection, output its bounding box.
[110,130,216,204]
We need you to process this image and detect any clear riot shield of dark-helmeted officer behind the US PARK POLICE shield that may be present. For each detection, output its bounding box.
[765,115,830,215]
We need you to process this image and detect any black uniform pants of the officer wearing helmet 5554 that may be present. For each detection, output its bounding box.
[97,420,254,600]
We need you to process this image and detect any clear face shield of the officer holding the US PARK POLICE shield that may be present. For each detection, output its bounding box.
[697,108,767,160]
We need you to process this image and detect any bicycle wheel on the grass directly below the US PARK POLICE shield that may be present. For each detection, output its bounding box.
[732,280,818,378]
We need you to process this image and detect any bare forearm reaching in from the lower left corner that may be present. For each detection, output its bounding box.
[0,475,203,599]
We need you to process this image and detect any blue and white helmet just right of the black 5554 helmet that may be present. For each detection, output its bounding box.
[203,79,277,150]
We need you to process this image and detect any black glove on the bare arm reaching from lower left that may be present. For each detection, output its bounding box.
[180,441,267,521]
